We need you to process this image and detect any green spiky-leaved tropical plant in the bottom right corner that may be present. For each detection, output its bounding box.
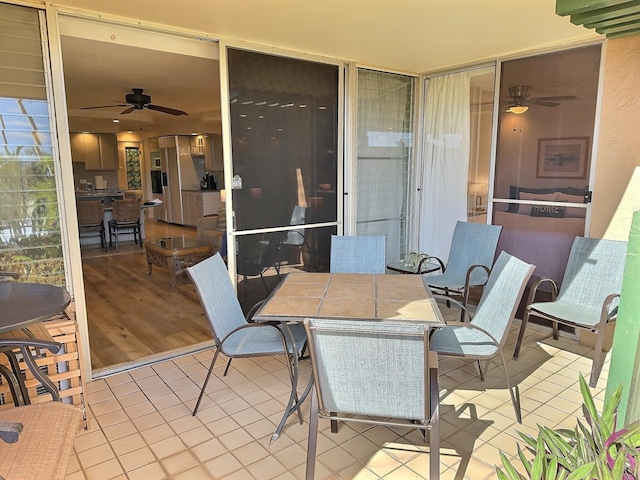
[496,375,640,480]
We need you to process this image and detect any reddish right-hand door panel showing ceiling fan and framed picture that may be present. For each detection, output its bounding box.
[493,45,600,282]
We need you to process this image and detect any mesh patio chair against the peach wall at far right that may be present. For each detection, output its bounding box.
[513,237,627,387]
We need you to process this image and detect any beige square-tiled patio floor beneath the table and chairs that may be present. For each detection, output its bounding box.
[67,318,608,480]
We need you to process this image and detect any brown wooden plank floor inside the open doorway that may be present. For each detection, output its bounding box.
[82,220,212,371]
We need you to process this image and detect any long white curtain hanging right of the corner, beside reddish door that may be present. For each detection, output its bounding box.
[420,72,471,260]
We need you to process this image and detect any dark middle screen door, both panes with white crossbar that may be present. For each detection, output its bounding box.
[228,48,339,306]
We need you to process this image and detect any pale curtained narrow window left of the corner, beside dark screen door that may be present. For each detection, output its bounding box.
[356,69,415,261]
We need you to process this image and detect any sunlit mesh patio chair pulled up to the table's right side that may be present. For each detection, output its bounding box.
[429,252,535,423]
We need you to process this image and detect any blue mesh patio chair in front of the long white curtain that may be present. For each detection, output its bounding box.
[425,221,502,307]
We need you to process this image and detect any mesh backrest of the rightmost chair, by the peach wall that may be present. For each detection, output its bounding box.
[557,237,627,315]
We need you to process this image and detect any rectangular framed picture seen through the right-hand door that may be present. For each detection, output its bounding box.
[536,137,589,178]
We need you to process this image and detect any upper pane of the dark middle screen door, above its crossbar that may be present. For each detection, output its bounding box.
[229,49,338,231]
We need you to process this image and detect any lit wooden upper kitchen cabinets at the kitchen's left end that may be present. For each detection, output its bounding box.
[71,133,118,171]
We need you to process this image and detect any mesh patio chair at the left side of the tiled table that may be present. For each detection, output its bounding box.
[187,253,306,416]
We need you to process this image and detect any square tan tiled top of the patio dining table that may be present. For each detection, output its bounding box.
[254,273,444,324]
